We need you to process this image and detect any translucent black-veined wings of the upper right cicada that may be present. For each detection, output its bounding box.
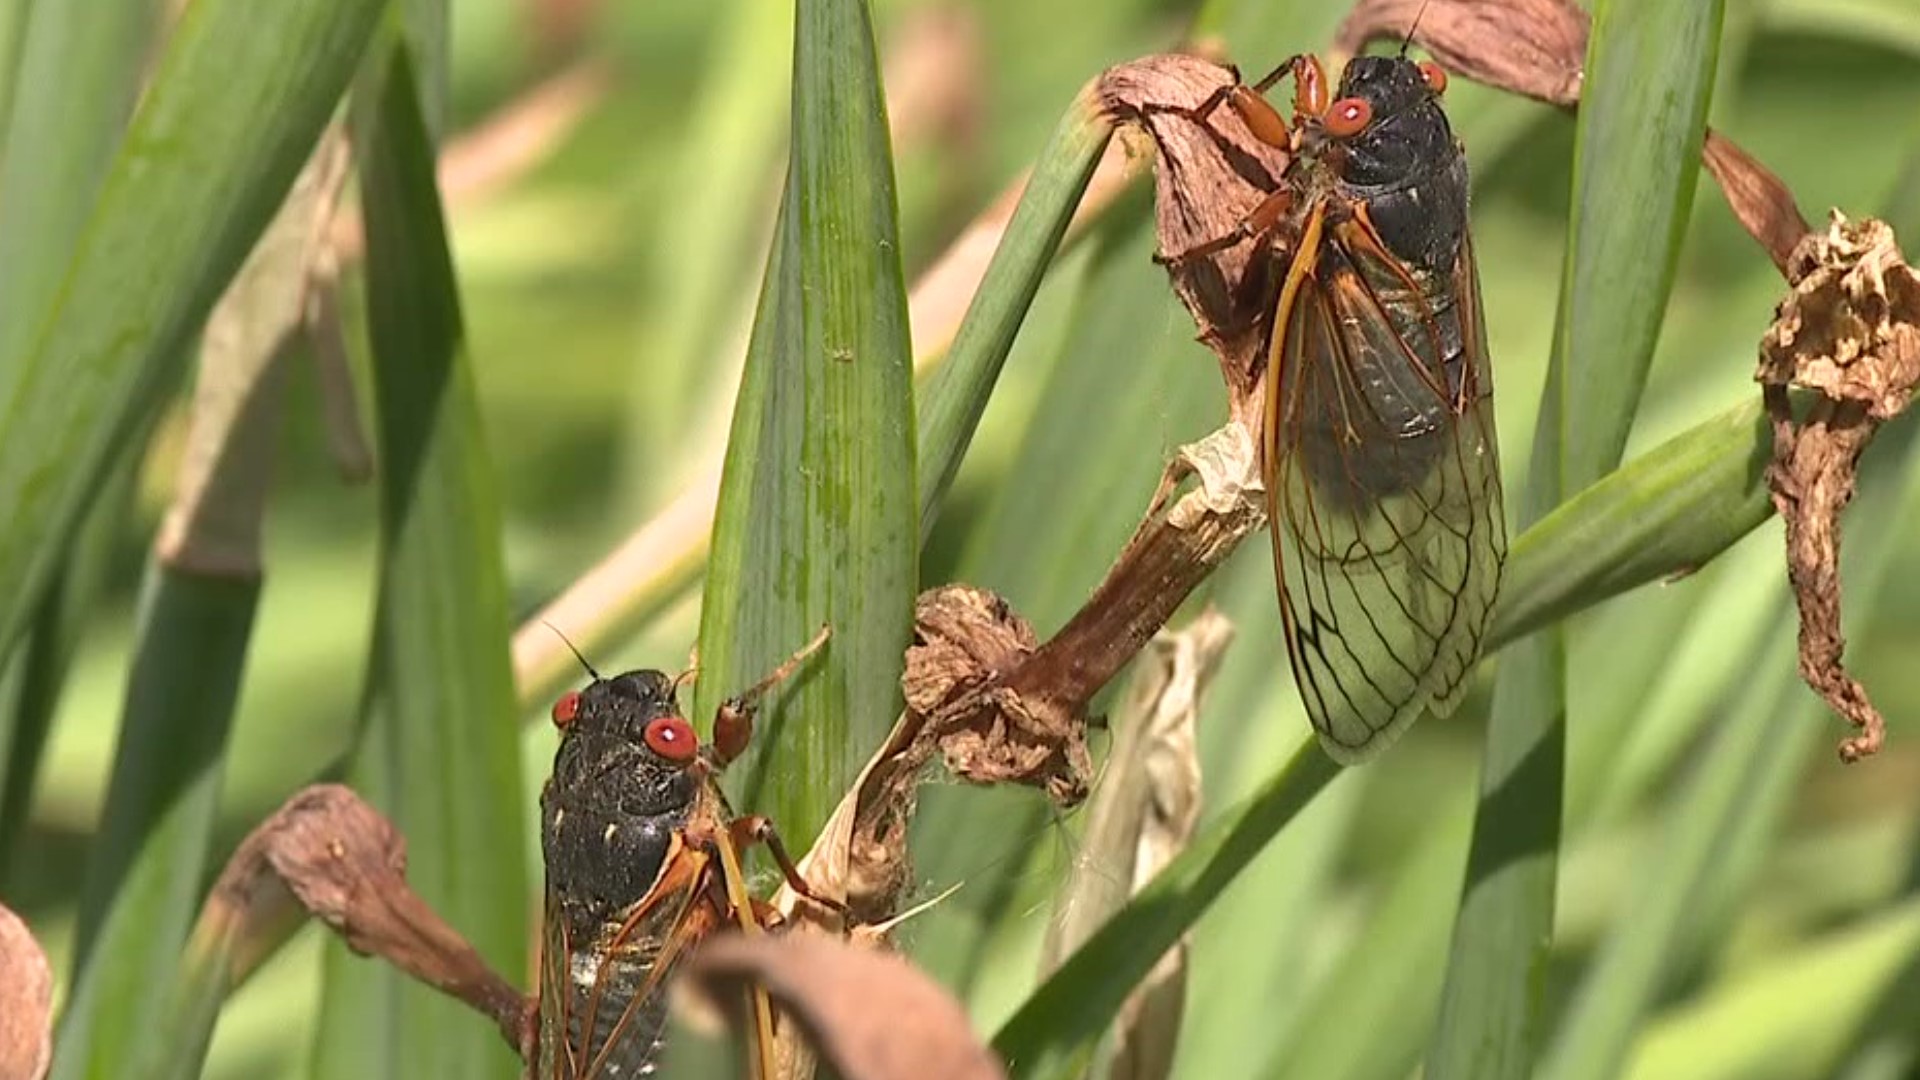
[1263,206,1507,763]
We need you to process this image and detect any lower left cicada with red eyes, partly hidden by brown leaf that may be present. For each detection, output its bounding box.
[530,630,831,1080]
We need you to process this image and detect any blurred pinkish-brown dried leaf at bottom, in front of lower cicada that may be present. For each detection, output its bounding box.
[689,934,1006,1080]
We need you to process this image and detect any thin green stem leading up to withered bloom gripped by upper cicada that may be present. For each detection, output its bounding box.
[920,94,1112,534]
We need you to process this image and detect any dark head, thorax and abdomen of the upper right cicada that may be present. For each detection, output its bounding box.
[1275,56,1490,509]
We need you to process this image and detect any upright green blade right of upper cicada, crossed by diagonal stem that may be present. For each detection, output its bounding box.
[1427,0,1722,1080]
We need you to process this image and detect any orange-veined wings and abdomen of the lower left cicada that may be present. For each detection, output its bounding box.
[540,844,714,1080]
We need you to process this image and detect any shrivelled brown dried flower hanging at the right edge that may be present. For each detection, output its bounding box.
[1755,211,1920,761]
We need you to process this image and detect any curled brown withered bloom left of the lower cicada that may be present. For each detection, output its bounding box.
[200,784,532,1057]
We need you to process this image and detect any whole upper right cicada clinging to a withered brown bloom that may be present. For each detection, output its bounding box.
[1171,50,1507,765]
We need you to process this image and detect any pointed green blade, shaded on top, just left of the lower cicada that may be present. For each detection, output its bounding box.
[315,44,530,1078]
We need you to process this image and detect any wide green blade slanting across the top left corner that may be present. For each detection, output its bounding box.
[0,0,384,664]
